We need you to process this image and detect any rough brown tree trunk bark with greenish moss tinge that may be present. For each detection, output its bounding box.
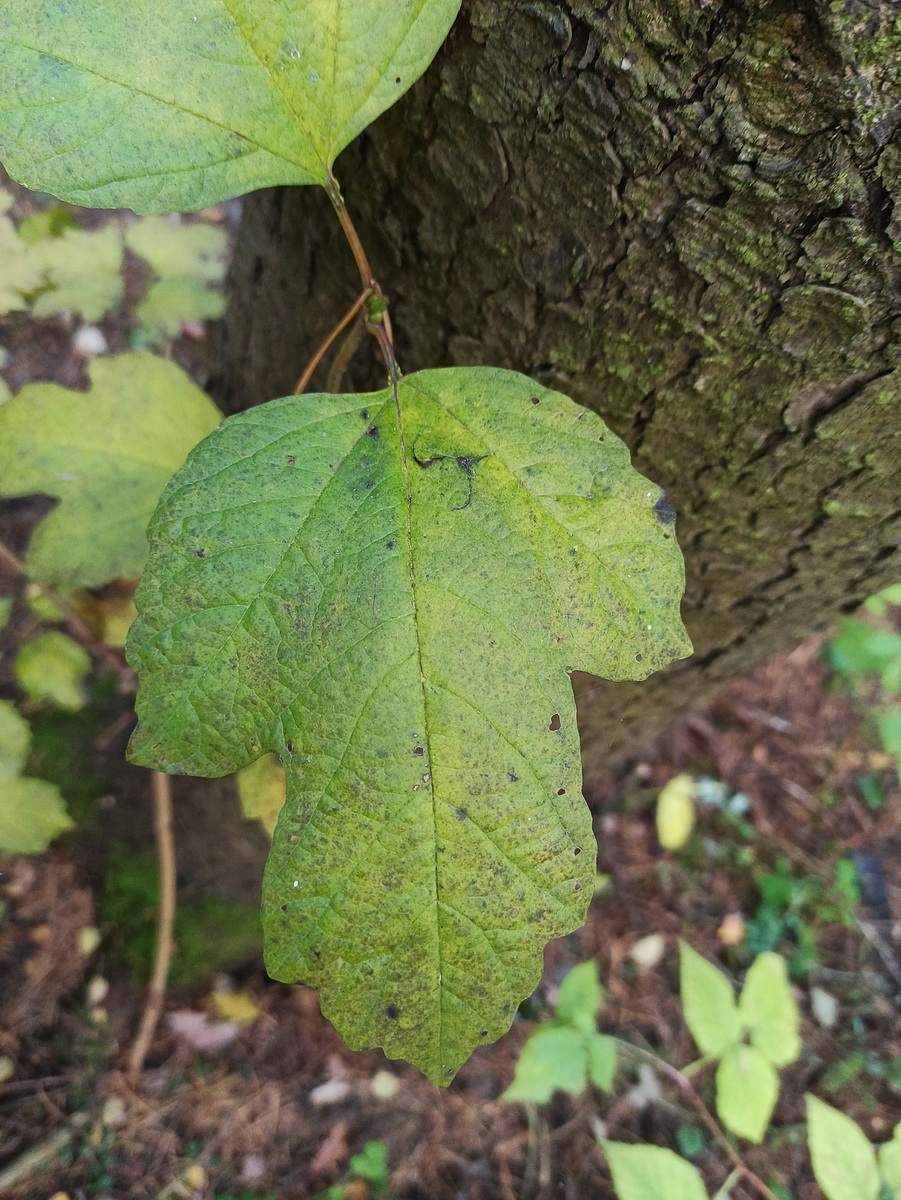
[218,0,901,770]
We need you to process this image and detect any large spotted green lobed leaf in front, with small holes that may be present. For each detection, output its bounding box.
[128,368,689,1082]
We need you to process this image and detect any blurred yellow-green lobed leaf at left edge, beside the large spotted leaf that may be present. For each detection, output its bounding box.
[0,354,220,587]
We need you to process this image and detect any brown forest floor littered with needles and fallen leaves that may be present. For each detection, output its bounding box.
[0,174,901,1200]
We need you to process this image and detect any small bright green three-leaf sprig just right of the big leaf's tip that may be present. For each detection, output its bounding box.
[504,962,617,1104]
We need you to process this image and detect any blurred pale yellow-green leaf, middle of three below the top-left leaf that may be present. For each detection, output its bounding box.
[31,226,125,320]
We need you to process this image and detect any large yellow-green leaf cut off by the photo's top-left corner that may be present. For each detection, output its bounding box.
[0,0,459,212]
